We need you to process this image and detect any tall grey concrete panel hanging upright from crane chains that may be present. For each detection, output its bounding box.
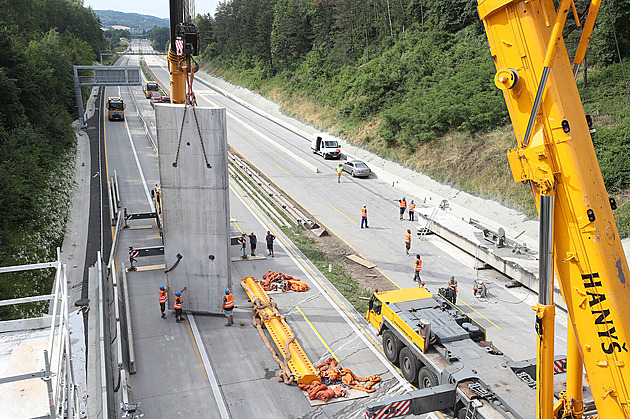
[155,104,231,313]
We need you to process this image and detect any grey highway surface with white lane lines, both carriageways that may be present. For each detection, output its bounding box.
[94,41,566,418]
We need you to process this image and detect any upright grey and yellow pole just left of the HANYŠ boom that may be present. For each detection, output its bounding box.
[535,195,555,419]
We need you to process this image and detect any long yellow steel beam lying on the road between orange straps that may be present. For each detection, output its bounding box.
[241,276,319,384]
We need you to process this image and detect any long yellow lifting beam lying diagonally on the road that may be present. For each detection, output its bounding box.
[241,277,319,384]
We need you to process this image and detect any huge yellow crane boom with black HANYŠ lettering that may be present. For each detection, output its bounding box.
[478,0,630,418]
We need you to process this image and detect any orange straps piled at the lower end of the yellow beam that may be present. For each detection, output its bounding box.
[298,358,381,403]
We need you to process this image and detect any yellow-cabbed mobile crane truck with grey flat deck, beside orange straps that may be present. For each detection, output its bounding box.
[365,287,563,419]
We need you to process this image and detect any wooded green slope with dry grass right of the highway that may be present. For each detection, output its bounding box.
[196,0,630,237]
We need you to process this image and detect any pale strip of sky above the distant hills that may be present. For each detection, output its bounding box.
[83,0,219,19]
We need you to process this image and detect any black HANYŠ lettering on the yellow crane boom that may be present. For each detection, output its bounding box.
[582,272,628,355]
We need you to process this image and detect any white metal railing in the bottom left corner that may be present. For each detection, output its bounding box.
[0,249,84,418]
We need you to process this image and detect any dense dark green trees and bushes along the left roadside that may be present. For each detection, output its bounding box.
[0,0,105,320]
